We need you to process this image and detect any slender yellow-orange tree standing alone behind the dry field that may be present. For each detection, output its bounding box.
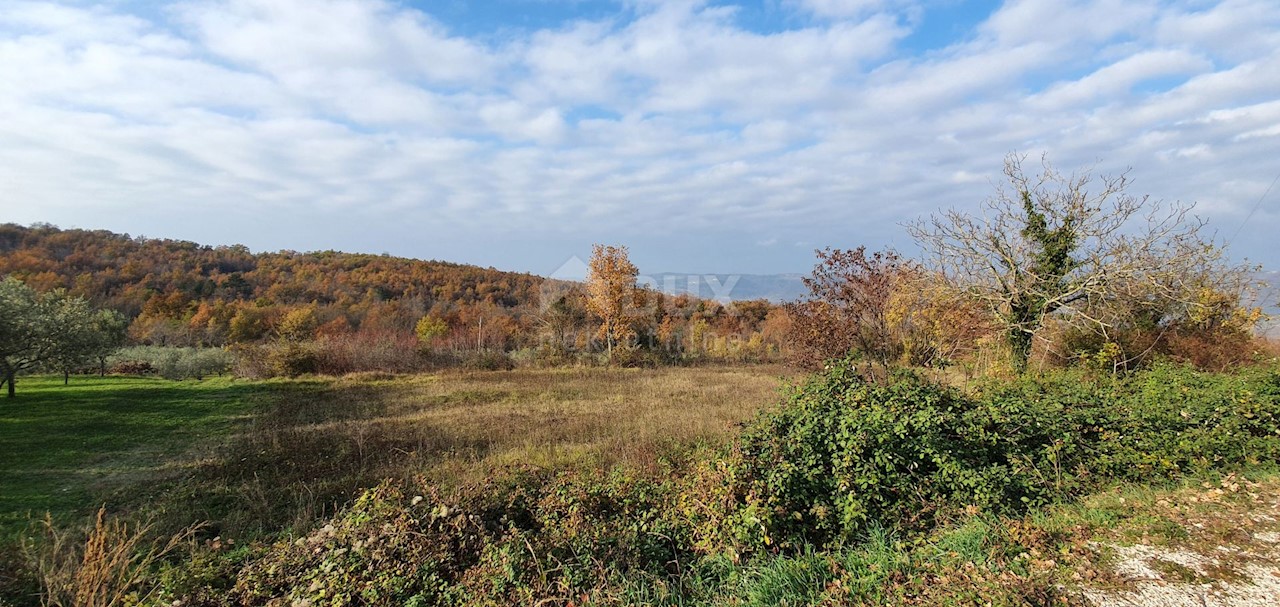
[586,245,640,360]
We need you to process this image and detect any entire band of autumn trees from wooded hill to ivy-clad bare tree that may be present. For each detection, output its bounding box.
[0,150,1275,378]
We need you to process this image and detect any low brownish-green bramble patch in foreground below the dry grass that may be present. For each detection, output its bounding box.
[207,469,690,606]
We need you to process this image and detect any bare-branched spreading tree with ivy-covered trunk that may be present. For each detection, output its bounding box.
[908,154,1242,373]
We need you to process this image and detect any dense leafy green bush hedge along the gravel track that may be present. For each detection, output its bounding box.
[681,361,1280,553]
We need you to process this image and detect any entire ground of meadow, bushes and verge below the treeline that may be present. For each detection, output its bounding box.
[0,361,1280,607]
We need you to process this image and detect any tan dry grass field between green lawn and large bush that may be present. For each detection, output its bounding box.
[227,366,788,499]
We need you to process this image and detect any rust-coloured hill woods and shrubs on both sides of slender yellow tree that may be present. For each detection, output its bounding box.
[0,224,786,375]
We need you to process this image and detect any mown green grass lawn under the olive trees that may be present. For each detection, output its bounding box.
[0,376,261,534]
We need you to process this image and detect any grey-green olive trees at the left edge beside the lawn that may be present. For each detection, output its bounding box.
[0,277,127,398]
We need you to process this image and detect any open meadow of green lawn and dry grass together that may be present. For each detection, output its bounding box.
[0,366,785,537]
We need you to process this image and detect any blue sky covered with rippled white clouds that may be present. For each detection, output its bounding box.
[0,0,1280,275]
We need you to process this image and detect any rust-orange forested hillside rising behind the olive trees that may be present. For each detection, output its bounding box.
[0,224,543,344]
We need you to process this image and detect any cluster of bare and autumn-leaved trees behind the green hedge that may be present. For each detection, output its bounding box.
[787,155,1262,373]
